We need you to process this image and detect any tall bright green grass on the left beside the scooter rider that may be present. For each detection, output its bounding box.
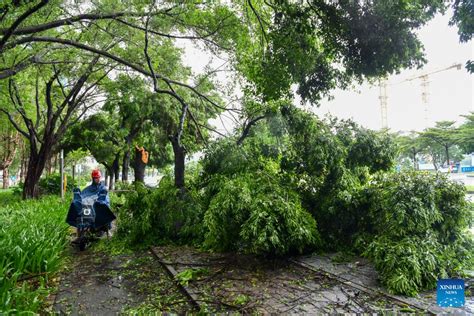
[0,191,68,314]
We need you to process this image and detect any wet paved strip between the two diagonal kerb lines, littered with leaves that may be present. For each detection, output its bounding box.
[153,247,430,315]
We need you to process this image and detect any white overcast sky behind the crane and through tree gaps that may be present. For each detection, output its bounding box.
[178,12,474,133]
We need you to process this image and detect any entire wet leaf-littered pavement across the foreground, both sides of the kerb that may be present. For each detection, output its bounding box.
[51,246,474,315]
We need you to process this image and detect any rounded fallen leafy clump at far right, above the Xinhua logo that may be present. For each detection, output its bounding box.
[359,172,474,296]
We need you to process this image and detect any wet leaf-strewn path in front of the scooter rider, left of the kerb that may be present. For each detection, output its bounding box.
[52,250,193,315]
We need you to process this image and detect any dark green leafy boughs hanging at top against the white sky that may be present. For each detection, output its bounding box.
[237,0,445,103]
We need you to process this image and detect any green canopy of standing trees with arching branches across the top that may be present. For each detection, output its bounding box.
[0,0,472,197]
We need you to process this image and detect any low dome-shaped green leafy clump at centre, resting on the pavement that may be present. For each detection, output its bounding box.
[204,172,319,255]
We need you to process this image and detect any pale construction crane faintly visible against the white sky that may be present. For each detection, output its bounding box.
[379,63,462,129]
